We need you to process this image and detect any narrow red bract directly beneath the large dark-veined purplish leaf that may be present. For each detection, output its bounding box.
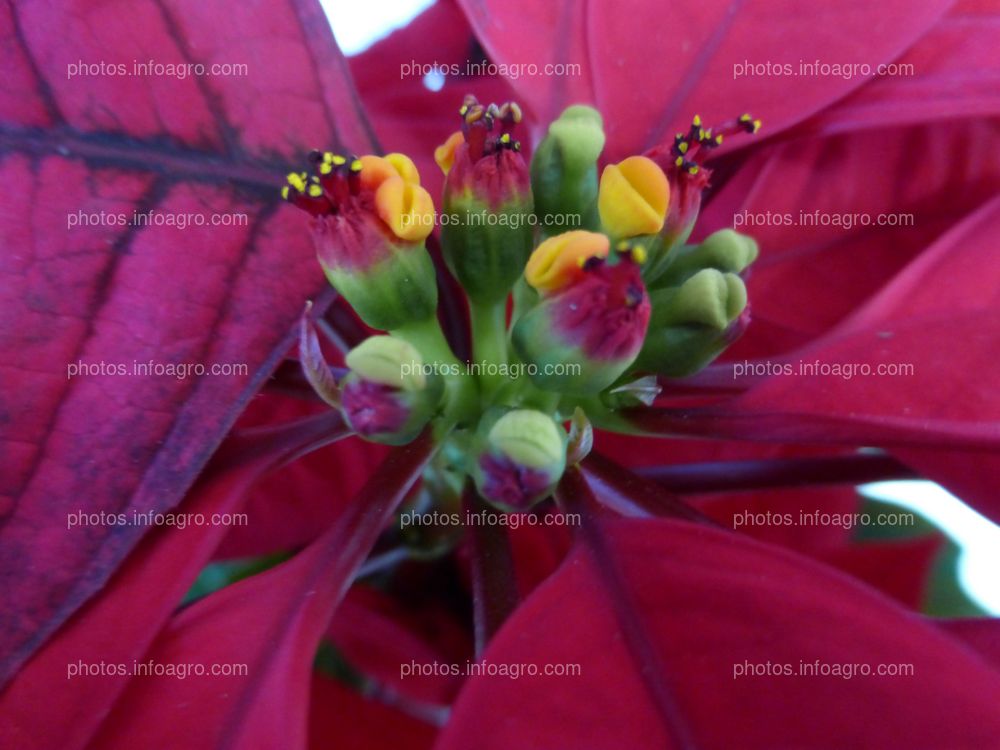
[0,412,352,750]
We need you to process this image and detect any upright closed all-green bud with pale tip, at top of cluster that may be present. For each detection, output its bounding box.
[531,104,604,231]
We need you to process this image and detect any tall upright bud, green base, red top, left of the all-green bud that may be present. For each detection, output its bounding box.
[434,96,534,304]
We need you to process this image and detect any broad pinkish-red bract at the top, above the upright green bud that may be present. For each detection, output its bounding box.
[462,0,949,160]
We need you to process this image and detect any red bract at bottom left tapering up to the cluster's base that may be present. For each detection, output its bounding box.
[83,435,433,750]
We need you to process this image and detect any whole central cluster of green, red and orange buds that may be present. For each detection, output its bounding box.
[283,96,760,512]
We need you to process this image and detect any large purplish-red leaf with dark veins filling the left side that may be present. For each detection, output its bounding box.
[0,0,371,676]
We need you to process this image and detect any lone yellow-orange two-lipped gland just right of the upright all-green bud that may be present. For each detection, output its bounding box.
[597,156,670,237]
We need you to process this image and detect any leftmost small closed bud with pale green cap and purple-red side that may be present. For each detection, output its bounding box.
[340,336,444,445]
